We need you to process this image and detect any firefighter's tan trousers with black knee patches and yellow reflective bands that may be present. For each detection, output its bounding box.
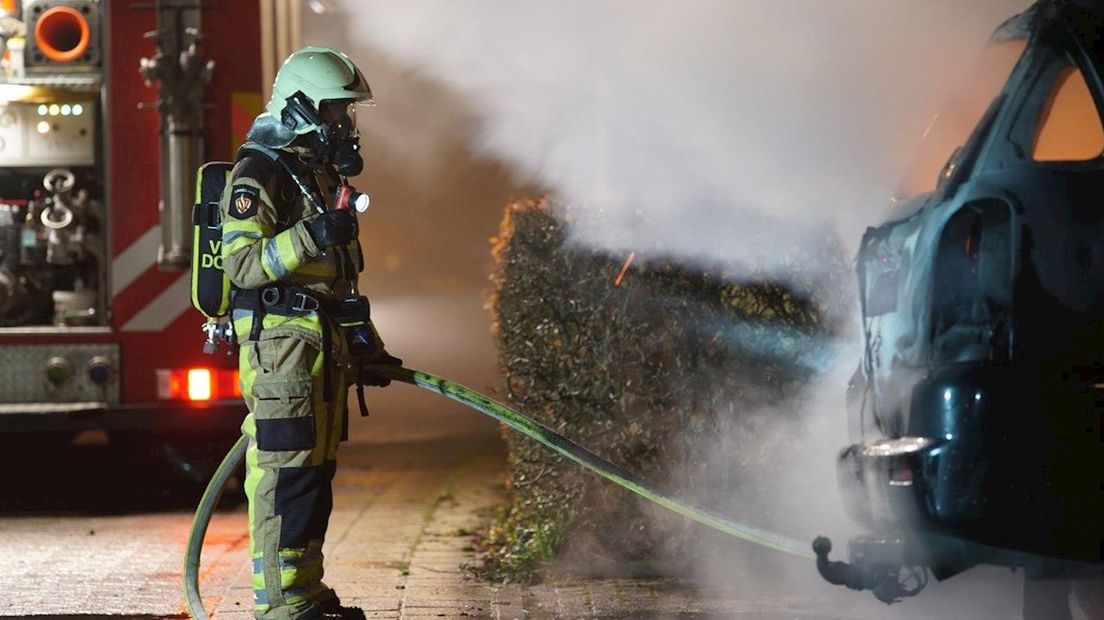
[234,316,348,620]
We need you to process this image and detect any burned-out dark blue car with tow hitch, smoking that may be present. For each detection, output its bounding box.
[815,0,1104,602]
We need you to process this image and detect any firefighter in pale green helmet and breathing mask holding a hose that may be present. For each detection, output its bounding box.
[220,47,401,619]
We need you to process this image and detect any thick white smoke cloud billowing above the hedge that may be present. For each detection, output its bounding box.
[330,0,1028,274]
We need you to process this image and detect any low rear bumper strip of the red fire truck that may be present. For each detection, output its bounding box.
[0,399,248,434]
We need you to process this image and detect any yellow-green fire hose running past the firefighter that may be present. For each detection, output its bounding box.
[184,366,815,620]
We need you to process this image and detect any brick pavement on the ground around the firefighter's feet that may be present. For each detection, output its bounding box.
[0,427,1028,620]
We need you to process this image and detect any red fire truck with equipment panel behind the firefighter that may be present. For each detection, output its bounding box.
[0,0,294,478]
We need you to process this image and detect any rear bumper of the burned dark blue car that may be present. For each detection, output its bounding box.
[837,364,1104,563]
